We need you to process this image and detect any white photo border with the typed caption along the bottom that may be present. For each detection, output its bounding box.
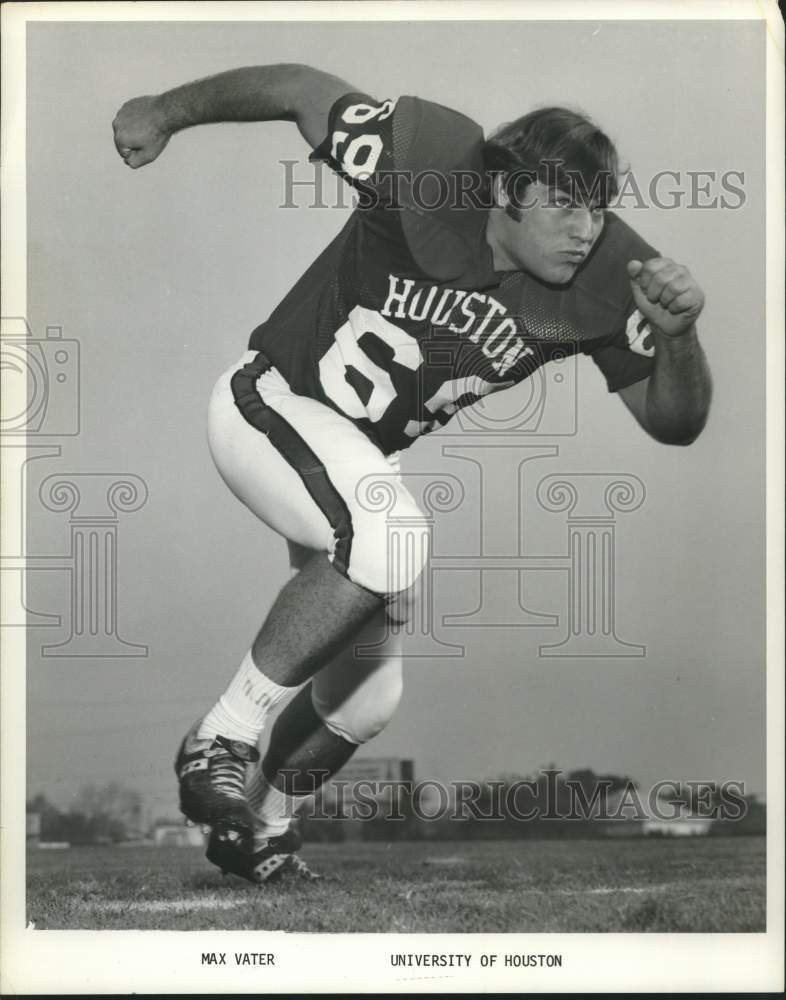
[0,0,784,994]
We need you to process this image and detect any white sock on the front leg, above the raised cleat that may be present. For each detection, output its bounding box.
[197,652,297,744]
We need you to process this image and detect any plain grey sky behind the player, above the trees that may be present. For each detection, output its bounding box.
[19,21,765,816]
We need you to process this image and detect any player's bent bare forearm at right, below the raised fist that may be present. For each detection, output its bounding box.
[647,326,712,444]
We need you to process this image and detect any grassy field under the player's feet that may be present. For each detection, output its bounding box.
[27,837,765,933]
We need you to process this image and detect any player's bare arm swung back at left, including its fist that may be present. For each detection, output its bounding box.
[112,63,355,169]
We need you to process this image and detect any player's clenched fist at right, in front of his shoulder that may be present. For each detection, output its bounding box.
[628,257,704,337]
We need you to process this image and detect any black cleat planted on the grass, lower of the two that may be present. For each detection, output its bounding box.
[207,830,321,885]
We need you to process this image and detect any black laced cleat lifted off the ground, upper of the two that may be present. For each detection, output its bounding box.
[175,722,259,838]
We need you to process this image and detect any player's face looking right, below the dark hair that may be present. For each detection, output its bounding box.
[488,181,604,285]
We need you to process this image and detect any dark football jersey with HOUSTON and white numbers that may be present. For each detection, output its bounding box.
[249,94,657,453]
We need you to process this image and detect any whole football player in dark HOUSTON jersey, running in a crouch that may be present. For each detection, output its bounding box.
[113,64,711,882]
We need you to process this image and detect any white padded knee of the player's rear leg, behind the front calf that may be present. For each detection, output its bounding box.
[311,657,403,745]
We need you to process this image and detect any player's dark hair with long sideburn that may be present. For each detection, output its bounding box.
[483,107,619,206]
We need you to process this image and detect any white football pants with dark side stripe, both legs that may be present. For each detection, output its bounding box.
[208,351,428,743]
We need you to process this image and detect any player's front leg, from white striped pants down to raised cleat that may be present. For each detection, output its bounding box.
[175,352,428,841]
